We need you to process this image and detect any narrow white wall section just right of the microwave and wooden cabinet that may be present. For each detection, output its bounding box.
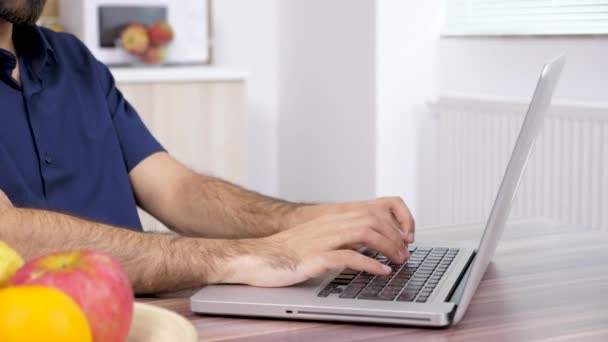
[213,0,279,195]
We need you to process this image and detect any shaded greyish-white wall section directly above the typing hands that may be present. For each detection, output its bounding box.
[279,0,376,201]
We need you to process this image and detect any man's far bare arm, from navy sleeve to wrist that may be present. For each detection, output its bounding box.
[129,152,312,239]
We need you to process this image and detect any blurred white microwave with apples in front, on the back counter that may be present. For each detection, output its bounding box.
[57,0,213,66]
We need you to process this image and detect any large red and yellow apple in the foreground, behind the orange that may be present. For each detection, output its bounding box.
[7,251,133,342]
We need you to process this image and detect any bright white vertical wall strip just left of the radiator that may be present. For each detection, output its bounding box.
[376,0,441,224]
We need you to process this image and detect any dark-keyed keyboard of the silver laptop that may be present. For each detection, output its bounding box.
[318,247,458,303]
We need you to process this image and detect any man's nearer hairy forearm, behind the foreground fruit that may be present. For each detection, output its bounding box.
[0,208,239,293]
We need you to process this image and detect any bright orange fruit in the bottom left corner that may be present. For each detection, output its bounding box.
[0,286,92,342]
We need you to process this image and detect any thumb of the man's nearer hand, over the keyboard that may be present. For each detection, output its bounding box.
[324,250,392,275]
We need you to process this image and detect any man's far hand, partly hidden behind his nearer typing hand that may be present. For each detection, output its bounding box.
[292,197,415,243]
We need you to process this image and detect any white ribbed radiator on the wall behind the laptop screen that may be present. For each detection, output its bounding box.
[432,97,608,231]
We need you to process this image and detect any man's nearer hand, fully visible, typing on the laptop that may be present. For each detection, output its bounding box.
[220,212,409,287]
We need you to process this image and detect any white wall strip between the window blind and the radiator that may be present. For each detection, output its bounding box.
[440,36,608,103]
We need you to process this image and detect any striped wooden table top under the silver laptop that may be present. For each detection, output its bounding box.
[141,220,608,341]
